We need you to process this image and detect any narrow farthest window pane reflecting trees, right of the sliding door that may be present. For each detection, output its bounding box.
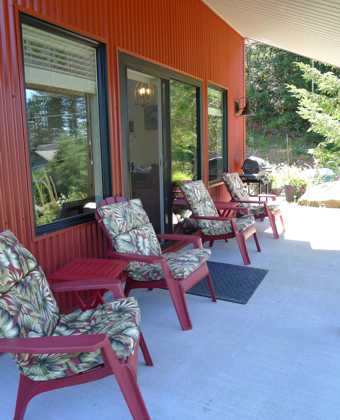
[208,87,223,181]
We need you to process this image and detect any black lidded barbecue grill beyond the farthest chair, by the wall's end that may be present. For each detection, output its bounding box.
[241,156,272,194]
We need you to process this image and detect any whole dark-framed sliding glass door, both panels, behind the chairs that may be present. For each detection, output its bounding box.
[119,53,201,232]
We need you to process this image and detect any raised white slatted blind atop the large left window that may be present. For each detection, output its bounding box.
[22,24,97,94]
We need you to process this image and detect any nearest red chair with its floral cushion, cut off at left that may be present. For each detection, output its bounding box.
[0,231,152,420]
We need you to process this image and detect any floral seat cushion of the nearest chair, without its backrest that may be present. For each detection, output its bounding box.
[16,297,140,381]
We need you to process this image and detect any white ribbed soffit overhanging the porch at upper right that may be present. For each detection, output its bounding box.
[203,0,340,67]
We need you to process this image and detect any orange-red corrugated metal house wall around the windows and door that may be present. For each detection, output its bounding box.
[0,0,244,308]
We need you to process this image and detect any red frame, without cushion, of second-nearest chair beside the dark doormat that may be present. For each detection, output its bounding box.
[96,196,216,330]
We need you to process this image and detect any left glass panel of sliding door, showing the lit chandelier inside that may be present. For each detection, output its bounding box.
[127,69,164,232]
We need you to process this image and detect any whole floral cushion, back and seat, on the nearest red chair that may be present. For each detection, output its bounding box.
[0,231,140,380]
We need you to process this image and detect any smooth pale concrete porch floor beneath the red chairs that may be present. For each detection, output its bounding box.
[0,205,340,420]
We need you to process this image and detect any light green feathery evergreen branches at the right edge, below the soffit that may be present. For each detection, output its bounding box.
[288,63,340,172]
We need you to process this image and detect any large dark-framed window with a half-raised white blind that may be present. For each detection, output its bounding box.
[22,18,109,233]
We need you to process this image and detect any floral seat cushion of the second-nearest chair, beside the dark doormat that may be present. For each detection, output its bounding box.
[128,248,211,281]
